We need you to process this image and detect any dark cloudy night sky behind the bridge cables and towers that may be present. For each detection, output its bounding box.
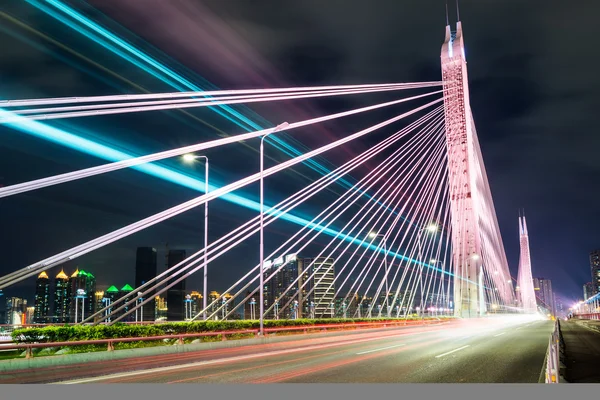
[0,0,600,310]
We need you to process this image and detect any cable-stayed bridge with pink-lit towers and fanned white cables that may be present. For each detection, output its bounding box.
[0,22,535,323]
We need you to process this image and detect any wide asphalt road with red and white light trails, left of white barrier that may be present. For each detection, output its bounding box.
[21,318,553,384]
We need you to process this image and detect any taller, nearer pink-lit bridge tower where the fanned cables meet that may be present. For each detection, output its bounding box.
[441,22,485,318]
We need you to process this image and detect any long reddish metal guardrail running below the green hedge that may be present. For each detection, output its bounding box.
[1,320,444,358]
